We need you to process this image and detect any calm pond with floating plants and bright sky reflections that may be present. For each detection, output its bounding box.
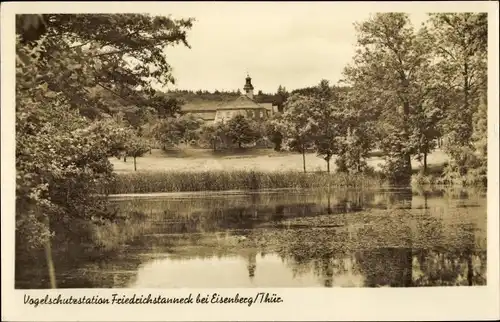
[16,188,487,288]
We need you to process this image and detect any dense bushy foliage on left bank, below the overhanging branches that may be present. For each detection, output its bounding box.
[16,48,119,250]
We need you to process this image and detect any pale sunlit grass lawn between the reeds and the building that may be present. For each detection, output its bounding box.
[110,149,448,173]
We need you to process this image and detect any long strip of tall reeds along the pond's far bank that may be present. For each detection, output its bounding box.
[107,170,384,194]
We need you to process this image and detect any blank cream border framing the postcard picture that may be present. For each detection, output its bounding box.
[1,1,500,321]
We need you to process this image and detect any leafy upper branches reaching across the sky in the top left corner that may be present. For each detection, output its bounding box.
[16,14,193,118]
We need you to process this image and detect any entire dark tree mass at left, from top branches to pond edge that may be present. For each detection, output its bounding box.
[16,14,191,260]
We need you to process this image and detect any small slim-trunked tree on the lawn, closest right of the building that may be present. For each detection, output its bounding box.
[280,94,317,173]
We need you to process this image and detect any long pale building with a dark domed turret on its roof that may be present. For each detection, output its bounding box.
[182,75,277,123]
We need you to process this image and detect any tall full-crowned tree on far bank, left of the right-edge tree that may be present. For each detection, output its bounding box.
[344,13,431,183]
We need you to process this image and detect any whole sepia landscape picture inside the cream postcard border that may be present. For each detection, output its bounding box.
[2,2,498,316]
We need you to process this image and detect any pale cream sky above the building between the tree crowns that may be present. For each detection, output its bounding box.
[156,2,426,93]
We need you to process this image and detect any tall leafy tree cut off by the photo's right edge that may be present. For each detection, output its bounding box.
[427,13,488,184]
